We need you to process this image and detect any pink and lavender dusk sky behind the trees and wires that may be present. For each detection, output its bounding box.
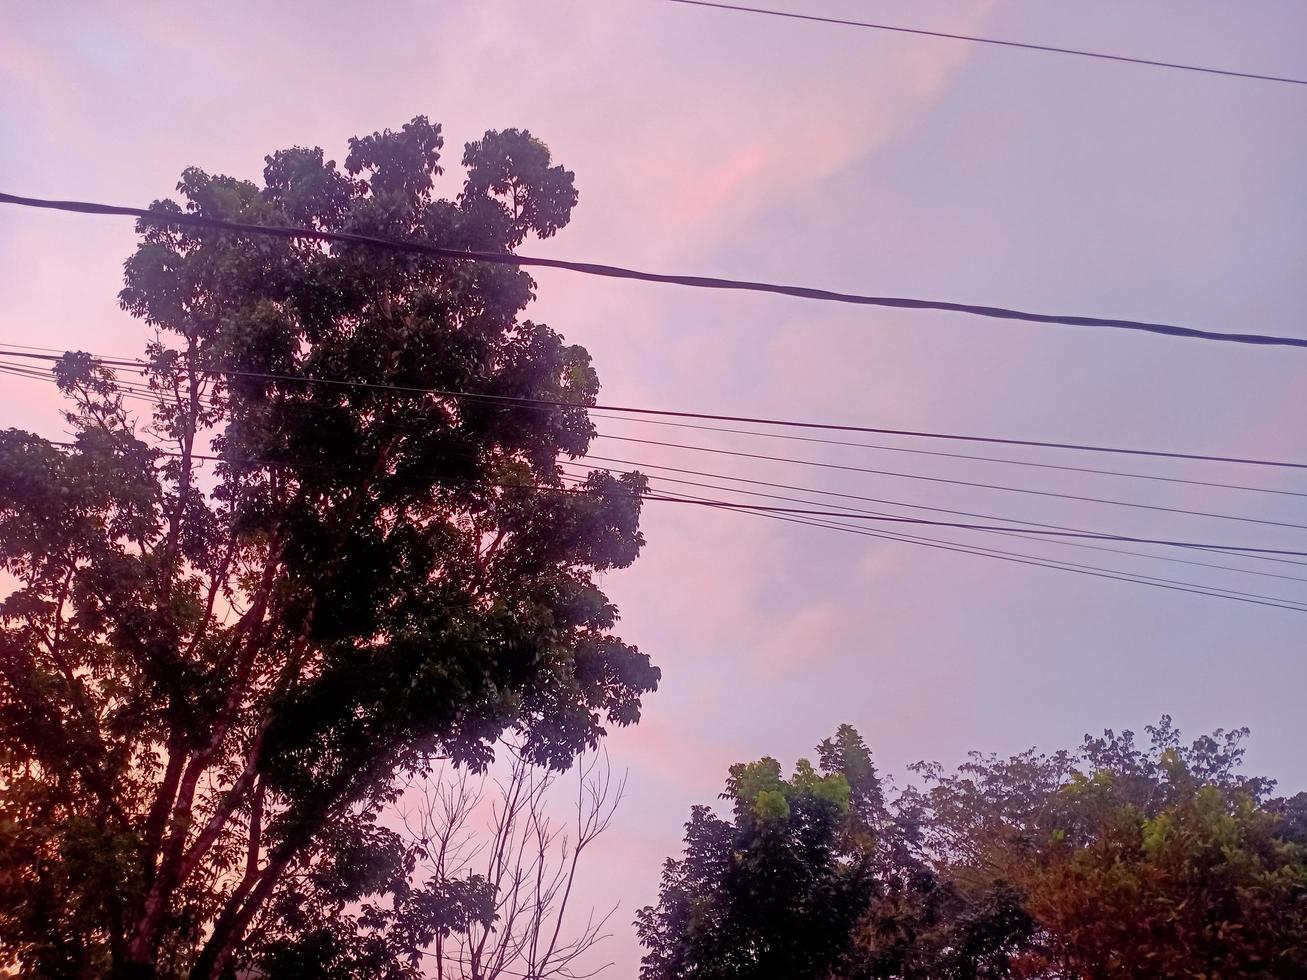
[0,0,1307,976]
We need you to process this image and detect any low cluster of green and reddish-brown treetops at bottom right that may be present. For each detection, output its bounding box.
[638,717,1307,980]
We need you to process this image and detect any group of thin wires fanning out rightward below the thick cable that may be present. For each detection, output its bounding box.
[0,345,1307,612]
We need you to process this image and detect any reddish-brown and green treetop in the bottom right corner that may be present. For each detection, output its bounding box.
[909,717,1307,977]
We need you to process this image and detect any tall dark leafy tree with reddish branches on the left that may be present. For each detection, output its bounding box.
[0,116,659,977]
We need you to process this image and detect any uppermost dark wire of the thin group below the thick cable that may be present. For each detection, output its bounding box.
[0,345,1307,469]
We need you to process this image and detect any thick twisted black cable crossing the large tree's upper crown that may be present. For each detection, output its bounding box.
[0,193,1307,348]
